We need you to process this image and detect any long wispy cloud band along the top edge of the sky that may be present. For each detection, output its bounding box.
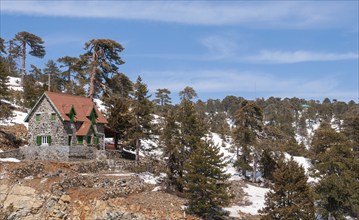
[1,0,358,28]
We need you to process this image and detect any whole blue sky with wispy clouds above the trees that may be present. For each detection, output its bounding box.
[0,0,359,102]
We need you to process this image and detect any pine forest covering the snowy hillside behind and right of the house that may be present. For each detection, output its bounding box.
[0,32,359,219]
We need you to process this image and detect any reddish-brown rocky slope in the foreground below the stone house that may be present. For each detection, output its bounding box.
[0,161,196,219]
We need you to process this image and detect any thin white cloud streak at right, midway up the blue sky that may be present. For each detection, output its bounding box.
[240,50,359,64]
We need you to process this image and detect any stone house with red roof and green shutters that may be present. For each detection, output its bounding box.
[25,92,107,149]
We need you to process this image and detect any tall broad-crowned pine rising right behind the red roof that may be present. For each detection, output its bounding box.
[82,39,124,98]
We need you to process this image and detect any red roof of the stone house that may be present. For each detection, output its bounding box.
[45,92,107,124]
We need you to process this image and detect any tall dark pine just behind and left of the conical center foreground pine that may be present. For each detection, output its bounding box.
[161,87,205,193]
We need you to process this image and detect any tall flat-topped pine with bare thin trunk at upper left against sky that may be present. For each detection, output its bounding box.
[13,31,46,83]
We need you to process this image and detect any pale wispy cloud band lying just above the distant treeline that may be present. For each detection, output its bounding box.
[141,69,356,101]
